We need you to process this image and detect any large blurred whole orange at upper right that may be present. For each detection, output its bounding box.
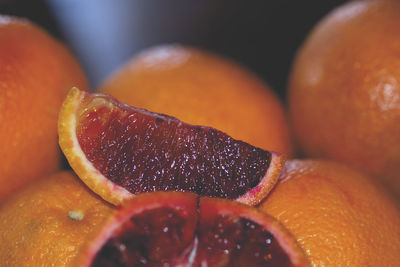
[288,0,400,199]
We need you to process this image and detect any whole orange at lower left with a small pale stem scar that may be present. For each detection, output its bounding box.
[0,172,114,267]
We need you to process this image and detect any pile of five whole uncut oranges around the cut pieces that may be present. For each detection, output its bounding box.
[0,0,400,266]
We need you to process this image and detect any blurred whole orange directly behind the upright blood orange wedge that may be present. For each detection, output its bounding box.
[100,45,292,154]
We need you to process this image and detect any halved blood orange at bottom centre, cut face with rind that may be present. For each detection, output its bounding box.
[78,192,307,267]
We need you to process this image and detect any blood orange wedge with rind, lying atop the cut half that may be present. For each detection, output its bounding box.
[58,88,285,205]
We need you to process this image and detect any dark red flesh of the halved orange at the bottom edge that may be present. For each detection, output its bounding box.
[91,195,293,266]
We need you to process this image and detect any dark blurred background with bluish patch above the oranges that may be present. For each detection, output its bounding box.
[0,0,346,98]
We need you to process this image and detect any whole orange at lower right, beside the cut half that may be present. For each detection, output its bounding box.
[260,160,400,266]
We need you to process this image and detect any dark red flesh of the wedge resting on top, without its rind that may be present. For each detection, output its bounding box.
[77,96,271,199]
